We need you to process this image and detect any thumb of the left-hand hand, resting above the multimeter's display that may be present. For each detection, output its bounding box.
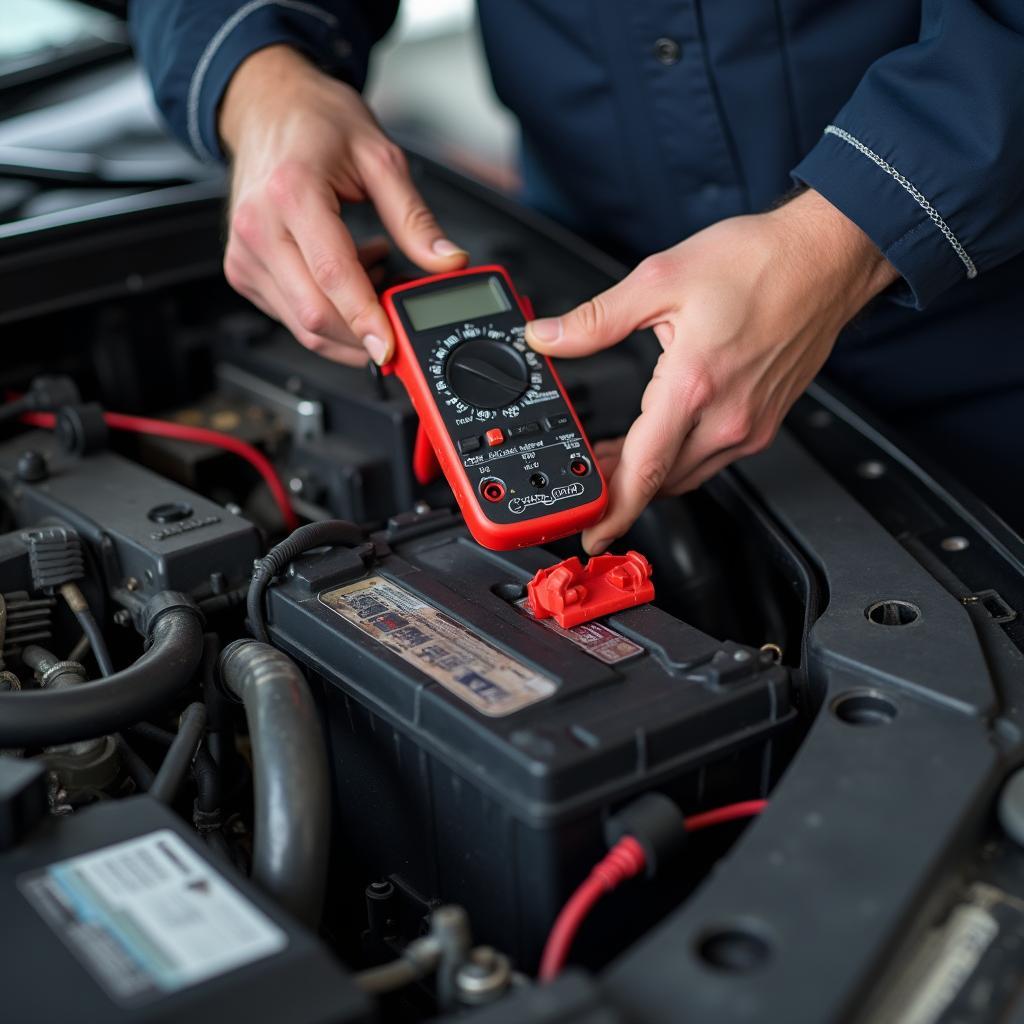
[357,145,469,273]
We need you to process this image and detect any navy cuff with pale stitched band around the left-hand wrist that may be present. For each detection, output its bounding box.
[185,0,370,161]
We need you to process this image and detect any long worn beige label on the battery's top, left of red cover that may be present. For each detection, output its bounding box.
[319,575,556,718]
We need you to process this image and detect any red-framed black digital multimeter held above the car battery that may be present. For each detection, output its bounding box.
[381,266,608,551]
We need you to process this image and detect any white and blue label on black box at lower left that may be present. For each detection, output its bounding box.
[17,828,288,1006]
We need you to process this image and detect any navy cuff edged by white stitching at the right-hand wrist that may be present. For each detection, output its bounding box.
[791,125,978,309]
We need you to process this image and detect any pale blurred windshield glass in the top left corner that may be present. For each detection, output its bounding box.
[0,0,124,76]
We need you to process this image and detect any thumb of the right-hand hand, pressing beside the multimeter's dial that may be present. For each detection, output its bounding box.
[526,260,669,358]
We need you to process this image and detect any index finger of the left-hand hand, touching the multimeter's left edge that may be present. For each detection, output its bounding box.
[285,191,394,365]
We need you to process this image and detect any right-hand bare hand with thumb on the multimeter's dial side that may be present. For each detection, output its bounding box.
[526,190,898,554]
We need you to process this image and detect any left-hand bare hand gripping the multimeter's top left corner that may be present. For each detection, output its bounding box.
[219,46,467,366]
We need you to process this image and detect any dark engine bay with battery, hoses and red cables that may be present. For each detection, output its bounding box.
[0,151,1024,1024]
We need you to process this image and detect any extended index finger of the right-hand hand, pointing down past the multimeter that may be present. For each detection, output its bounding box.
[583,362,699,555]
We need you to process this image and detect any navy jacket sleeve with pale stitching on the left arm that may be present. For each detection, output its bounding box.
[128,0,398,160]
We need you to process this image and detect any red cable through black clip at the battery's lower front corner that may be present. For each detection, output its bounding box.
[540,800,768,981]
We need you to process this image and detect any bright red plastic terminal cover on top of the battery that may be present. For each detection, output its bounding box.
[526,551,654,629]
